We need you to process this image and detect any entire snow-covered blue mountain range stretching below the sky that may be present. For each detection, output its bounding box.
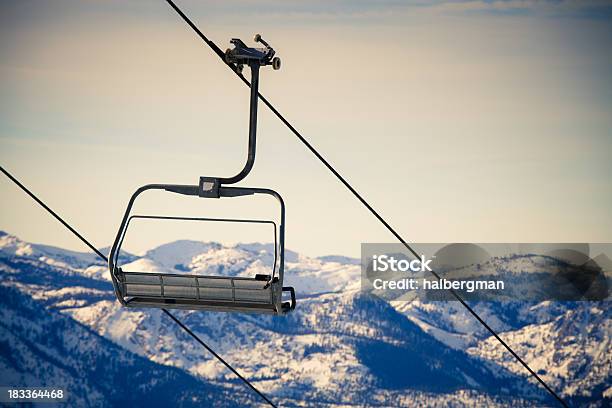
[0,234,612,406]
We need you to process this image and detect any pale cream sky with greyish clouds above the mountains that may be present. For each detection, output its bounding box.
[0,0,612,257]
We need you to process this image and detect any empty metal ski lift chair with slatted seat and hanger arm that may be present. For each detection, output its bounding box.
[108,35,296,315]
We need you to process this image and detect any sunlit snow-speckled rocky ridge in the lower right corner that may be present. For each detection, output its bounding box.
[468,302,612,402]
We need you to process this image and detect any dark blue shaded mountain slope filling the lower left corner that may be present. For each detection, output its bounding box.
[0,285,253,407]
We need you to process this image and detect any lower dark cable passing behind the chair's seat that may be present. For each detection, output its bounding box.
[0,166,276,408]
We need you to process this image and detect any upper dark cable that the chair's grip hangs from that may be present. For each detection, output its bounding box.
[166,0,568,407]
